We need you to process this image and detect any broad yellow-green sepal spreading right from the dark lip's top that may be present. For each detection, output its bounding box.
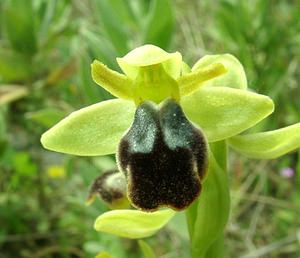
[181,87,274,142]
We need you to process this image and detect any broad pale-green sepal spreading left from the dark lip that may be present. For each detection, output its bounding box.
[41,99,135,156]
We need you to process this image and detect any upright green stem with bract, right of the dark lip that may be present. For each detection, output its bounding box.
[186,141,230,258]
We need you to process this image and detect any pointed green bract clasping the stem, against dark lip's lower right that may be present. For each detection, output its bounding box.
[192,154,230,258]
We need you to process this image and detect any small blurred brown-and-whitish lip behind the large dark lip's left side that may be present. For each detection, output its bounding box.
[86,170,129,209]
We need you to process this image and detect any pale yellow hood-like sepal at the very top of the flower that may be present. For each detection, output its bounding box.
[117,45,182,80]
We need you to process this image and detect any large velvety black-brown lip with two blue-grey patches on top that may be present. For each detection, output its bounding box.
[118,99,208,211]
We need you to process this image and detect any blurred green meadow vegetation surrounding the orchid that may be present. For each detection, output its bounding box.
[0,0,300,258]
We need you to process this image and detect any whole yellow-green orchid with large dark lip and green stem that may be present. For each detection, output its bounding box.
[41,45,300,258]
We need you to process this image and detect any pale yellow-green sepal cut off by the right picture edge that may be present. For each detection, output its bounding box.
[228,123,300,159]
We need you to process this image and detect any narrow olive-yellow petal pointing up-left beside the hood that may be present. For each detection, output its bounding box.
[91,60,132,99]
